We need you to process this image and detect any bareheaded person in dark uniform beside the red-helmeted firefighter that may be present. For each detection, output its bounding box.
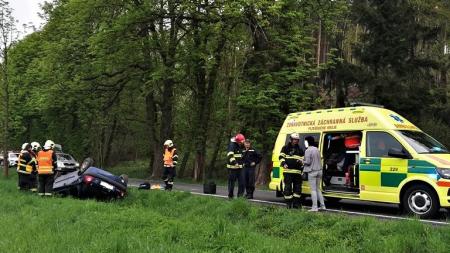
[242,139,262,199]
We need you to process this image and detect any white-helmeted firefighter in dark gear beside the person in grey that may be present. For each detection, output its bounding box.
[279,133,305,208]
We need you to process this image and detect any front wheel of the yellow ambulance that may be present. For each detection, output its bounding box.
[402,185,439,219]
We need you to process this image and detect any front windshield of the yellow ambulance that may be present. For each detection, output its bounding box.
[398,131,449,154]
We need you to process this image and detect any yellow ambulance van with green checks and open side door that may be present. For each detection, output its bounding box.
[269,106,450,218]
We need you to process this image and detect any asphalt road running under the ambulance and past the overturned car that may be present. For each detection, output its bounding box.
[128,179,450,225]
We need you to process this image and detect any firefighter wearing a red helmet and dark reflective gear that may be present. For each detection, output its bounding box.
[227,134,245,199]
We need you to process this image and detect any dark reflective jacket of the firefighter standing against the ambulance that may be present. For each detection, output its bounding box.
[279,142,305,174]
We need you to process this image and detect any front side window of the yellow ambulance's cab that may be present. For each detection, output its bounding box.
[366,132,404,157]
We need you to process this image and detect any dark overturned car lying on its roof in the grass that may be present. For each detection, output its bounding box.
[53,158,128,199]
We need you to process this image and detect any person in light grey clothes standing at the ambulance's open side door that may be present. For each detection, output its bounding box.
[303,136,326,212]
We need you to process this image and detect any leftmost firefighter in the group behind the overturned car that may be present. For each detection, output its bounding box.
[17,143,36,190]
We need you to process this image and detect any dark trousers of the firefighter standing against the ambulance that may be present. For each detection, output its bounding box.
[283,173,302,208]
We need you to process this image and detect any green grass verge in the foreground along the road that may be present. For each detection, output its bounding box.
[0,176,450,253]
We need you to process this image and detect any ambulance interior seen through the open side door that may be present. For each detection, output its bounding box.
[321,131,362,193]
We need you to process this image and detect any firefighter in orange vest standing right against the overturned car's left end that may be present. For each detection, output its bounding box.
[37,140,57,196]
